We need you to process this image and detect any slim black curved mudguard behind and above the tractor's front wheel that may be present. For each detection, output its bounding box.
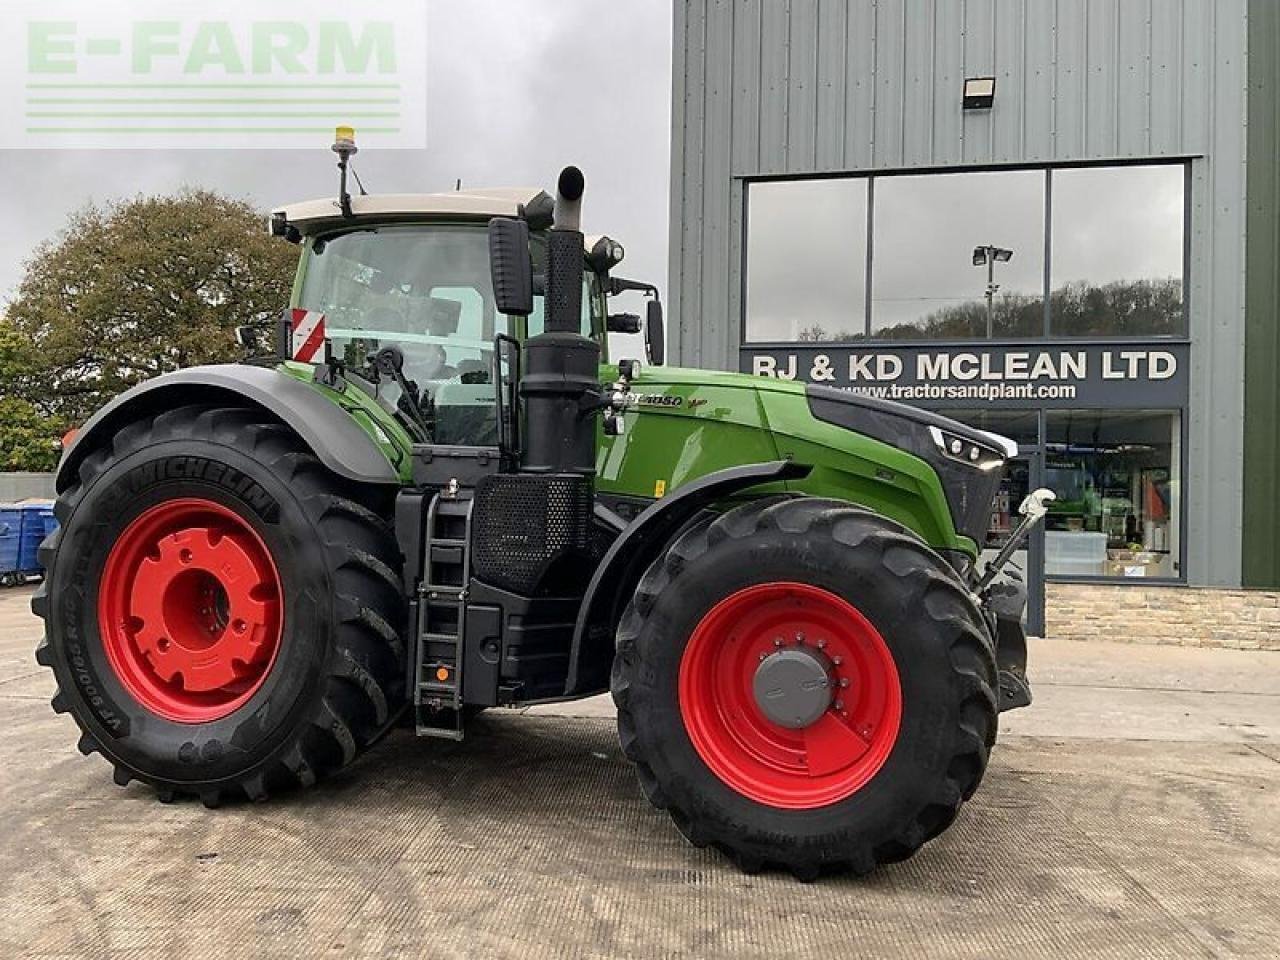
[564,460,812,696]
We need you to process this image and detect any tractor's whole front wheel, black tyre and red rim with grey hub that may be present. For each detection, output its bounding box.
[612,498,996,879]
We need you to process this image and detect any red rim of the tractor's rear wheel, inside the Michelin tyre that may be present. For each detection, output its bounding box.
[97,498,283,723]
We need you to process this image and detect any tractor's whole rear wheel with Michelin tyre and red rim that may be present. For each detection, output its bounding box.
[32,406,404,805]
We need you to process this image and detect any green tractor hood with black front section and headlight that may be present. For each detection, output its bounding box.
[599,366,1018,561]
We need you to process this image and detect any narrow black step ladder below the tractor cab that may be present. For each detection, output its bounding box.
[413,492,471,740]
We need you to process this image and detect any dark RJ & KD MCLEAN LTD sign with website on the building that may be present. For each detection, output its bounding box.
[740,342,1190,407]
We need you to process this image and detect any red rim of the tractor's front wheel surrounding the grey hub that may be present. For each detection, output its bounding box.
[680,582,902,809]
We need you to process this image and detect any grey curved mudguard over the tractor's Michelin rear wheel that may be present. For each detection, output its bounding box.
[55,364,399,493]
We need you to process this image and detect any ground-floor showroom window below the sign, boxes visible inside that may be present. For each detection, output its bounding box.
[1044,411,1181,579]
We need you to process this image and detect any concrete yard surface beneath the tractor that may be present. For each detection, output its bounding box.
[0,590,1280,959]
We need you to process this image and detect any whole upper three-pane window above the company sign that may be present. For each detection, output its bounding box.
[744,163,1188,343]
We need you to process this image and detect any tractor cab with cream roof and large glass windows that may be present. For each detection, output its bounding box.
[271,188,662,445]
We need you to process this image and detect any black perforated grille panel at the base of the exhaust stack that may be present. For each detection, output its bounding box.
[471,474,593,594]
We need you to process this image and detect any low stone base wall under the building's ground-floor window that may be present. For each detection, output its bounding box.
[1044,584,1280,650]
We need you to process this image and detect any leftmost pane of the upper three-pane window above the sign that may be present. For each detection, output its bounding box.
[746,178,868,343]
